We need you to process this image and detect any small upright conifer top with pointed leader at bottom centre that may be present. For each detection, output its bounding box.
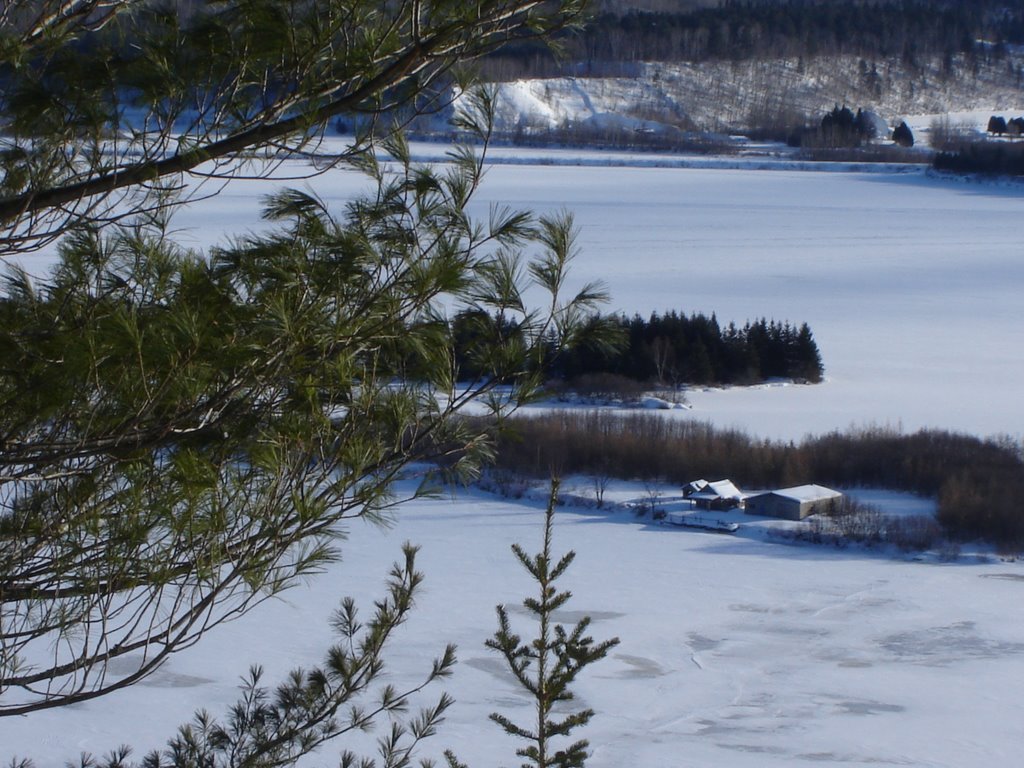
[486,480,618,768]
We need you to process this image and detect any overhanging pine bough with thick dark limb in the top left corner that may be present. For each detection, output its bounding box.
[0,0,583,255]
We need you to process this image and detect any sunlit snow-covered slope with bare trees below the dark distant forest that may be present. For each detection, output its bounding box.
[438,52,1024,143]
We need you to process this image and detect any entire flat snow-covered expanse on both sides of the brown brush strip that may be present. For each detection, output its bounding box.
[8,150,1024,768]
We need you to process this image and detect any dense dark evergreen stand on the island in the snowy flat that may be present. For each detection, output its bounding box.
[553,311,824,385]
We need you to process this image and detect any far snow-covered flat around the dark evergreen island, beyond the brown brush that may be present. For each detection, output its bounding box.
[176,145,1024,439]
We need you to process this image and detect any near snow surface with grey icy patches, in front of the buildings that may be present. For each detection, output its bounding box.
[8,481,1024,768]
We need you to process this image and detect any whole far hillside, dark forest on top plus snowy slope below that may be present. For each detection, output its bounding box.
[411,0,1024,150]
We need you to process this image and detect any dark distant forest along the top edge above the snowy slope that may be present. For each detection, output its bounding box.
[484,0,1024,79]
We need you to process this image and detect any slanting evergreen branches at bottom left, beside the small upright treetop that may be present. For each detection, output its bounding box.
[9,544,455,768]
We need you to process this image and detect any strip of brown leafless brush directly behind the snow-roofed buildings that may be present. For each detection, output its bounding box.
[485,410,1024,552]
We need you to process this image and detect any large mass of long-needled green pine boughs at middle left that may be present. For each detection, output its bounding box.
[0,123,602,715]
